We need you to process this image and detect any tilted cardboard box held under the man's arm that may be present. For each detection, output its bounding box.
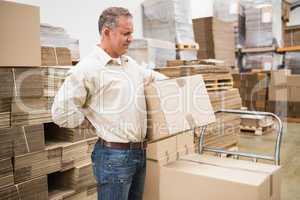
[145,75,215,140]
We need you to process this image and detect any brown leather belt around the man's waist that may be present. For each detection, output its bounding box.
[97,138,147,149]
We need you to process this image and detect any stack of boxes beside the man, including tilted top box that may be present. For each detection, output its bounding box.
[144,75,215,200]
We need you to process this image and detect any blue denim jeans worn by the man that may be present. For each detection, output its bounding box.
[92,142,146,200]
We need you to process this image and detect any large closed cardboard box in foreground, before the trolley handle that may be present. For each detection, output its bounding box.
[160,155,277,200]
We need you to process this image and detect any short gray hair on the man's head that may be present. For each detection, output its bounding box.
[98,7,132,34]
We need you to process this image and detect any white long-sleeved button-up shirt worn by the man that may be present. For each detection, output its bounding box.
[52,46,166,143]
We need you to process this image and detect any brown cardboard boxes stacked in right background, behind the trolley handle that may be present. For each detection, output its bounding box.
[233,69,300,118]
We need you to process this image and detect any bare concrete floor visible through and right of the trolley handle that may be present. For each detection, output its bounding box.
[239,123,300,200]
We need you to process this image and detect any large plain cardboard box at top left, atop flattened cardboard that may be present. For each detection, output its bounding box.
[0,1,41,67]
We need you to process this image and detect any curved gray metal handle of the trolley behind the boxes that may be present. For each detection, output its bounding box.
[199,109,283,165]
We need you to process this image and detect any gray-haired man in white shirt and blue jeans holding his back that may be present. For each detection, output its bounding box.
[52,7,166,200]
